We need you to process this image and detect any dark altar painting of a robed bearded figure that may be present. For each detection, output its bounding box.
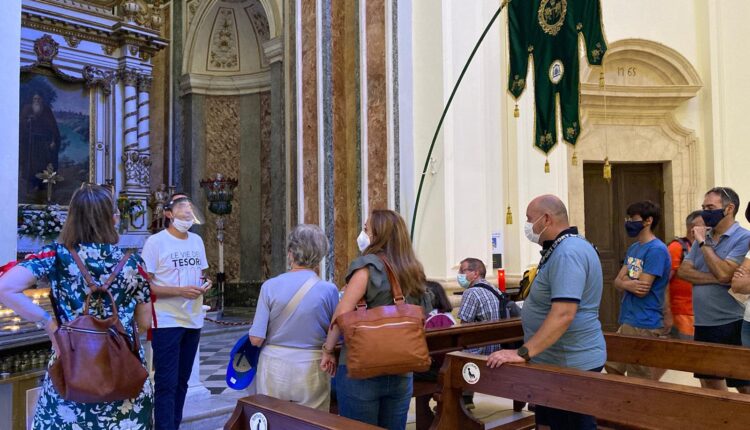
[18,74,90,205]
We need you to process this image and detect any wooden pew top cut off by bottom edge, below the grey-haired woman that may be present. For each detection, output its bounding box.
[224,395,380,430]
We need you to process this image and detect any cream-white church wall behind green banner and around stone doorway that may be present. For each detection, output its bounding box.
[408,0,750,278]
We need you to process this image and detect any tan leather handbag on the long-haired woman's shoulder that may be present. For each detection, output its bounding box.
[335,256,431,379]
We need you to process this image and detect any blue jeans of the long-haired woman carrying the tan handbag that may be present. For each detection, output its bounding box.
[336,365,413,430]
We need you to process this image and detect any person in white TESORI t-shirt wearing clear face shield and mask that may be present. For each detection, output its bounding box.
[141,194,211,430]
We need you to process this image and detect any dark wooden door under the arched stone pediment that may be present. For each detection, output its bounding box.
[583,163,664,331]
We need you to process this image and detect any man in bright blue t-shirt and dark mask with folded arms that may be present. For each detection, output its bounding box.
[604,200,672,379]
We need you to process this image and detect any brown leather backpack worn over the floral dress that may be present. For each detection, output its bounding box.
[49,248,148,403]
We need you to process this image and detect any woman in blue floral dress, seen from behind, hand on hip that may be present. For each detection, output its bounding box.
[0,184,153,430]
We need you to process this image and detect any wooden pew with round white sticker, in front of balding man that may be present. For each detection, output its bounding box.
[431,352,750,430]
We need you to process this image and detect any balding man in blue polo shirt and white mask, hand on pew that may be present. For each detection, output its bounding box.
[487,195,607,430]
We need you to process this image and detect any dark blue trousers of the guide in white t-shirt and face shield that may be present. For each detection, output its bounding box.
[151,327,201,430]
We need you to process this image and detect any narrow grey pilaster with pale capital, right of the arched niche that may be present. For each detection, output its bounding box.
[263,37,290,276]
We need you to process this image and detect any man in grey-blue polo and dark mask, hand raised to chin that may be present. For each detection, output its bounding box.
[678,187,750,394]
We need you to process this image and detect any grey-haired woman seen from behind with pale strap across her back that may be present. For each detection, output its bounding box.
[249,224,339,411]
